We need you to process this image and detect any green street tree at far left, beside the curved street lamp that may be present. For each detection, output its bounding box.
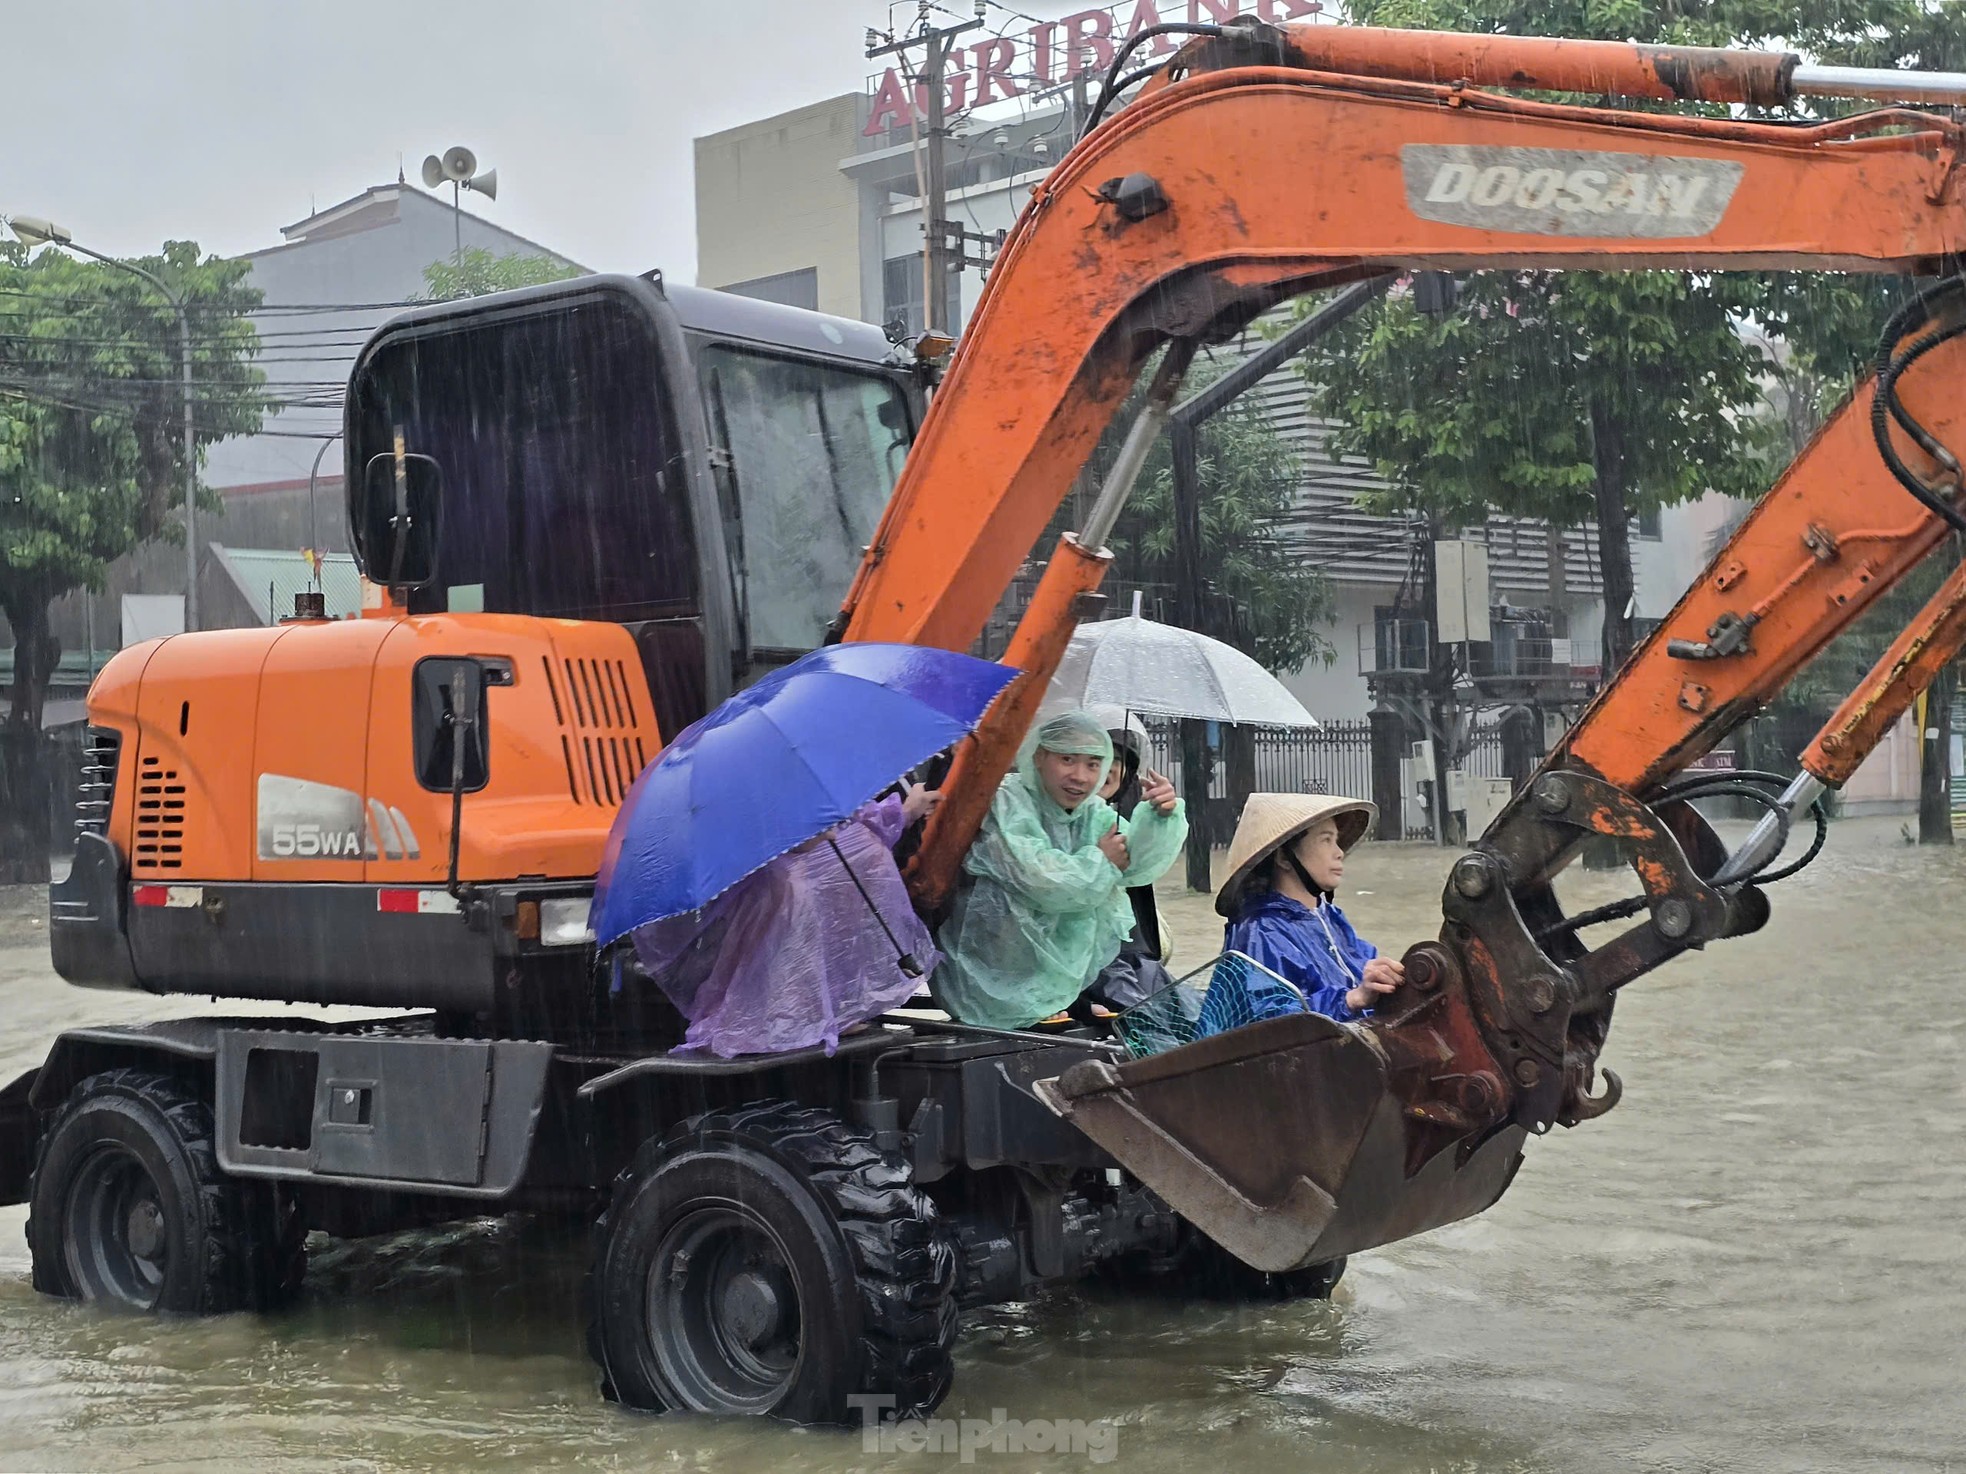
[0,242,265,879]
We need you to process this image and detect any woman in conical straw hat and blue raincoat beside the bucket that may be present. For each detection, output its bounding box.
[1203,794,1406,1028]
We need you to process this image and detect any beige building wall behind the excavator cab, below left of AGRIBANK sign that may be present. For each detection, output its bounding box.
[696,92,881,316]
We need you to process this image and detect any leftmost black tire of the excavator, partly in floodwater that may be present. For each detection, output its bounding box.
[28,1069,307,1315]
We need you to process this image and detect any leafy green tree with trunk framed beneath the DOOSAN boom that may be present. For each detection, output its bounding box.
[1303,271,1765,668]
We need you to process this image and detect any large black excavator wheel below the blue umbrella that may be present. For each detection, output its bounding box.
[588,1103,955,1423]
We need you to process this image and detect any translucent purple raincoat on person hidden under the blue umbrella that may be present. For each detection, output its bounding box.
[631,798,942,1057]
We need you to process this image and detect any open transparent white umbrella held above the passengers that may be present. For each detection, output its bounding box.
[1046,595,1317,727]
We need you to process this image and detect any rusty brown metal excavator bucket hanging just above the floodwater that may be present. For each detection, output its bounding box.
[1034,1014,1528,1274]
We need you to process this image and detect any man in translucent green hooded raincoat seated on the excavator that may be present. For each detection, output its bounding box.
[932,711,1187,1028]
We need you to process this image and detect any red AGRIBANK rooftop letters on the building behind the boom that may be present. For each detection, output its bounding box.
[861,0,1323,138]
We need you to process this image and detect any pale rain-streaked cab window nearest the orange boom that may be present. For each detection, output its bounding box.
[698,342,912,658]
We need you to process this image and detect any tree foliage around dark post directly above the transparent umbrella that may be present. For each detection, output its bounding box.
[1095,357,1333,670]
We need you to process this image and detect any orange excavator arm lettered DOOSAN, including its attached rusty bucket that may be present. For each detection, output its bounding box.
[843,24,1966,1270]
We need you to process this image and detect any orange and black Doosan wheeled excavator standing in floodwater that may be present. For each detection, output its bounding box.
[0,22,1966,1421]
